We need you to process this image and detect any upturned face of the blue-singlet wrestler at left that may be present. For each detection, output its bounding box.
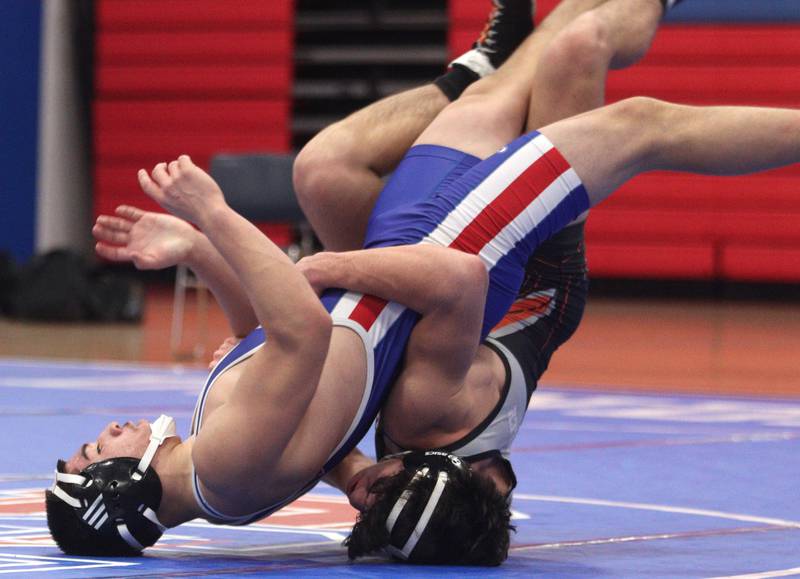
[67,420,150,473]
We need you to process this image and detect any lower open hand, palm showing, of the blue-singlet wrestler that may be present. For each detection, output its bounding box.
[92,205,199,269]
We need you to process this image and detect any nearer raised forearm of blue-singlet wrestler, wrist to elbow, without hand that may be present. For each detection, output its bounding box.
[198,206,327,336]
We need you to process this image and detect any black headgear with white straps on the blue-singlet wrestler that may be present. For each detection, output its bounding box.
[46,415,176,555]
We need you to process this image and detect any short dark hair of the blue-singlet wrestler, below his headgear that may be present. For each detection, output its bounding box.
[44,491,143,557]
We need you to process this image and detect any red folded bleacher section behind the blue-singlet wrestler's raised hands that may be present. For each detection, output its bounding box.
[93,0,294,218]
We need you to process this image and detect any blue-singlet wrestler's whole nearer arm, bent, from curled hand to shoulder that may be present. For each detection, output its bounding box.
[139,155,331,495]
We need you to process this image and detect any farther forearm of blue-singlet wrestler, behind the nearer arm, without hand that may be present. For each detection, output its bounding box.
[186,232,258,338]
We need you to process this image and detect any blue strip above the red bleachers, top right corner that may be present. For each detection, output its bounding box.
[667,0,800,23]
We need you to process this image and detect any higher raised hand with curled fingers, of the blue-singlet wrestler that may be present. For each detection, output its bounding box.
[137,155,225,228]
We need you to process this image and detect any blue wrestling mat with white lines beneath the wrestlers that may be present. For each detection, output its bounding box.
[0,360,800,578]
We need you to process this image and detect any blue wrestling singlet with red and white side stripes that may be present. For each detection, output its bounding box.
[192,132,589,524]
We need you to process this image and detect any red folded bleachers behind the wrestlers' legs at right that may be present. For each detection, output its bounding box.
[450,0,800,282]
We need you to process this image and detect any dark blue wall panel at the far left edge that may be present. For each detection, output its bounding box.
[0,0,42,260]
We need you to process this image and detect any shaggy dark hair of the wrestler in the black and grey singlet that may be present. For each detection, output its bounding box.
[344,469,514,566]
